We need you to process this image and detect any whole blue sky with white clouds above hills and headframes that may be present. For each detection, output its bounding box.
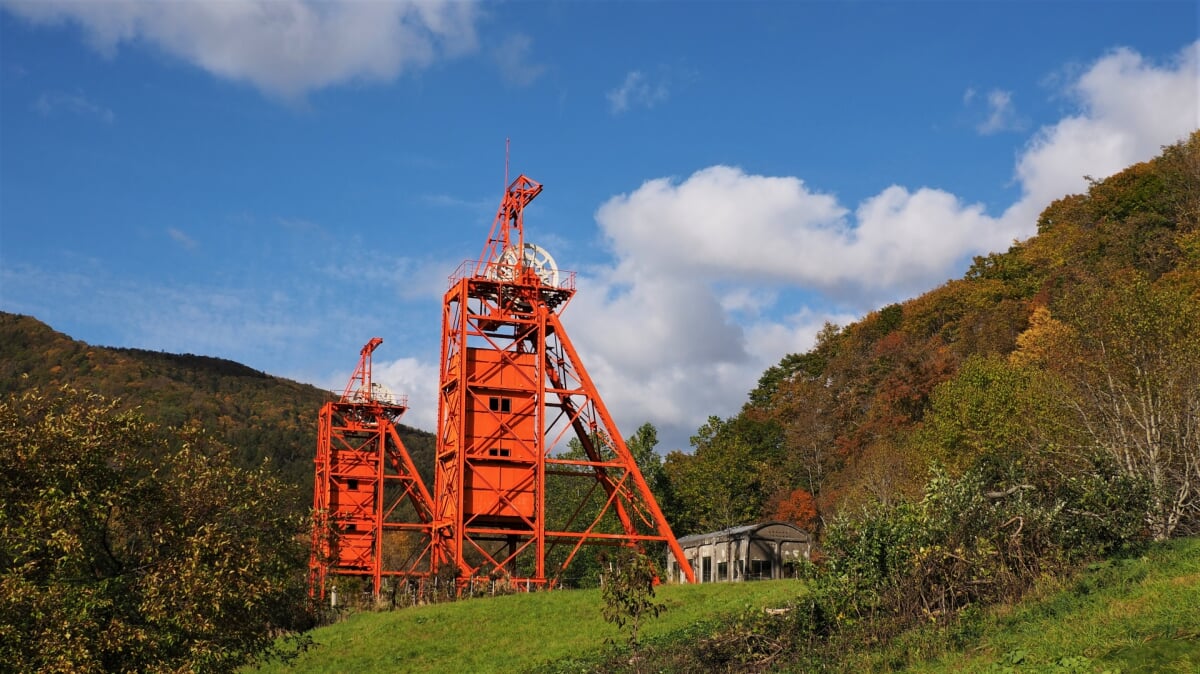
[0,0,1200,450]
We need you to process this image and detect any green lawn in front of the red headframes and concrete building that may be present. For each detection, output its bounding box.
[250,580,804,673]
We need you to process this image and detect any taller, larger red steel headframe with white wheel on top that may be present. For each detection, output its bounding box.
[433,175,695,589]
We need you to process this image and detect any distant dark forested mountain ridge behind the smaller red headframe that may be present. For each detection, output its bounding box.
[0,312,434,508]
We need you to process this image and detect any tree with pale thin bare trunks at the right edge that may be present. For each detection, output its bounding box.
[1056,275,1200,538]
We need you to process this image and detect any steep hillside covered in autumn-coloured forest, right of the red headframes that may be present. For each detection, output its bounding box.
[665,133,1200,537]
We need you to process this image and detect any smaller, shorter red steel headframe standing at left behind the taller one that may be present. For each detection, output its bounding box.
[308,337,436,597]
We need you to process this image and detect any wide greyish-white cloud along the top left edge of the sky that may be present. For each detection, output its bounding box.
[4,0,478,98]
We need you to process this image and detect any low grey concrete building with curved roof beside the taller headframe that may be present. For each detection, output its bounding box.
[667,522,812,583]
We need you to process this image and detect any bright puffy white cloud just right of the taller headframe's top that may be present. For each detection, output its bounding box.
[596,166,1012,293]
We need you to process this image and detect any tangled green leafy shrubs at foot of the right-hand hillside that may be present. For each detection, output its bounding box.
[817,460,1146,636]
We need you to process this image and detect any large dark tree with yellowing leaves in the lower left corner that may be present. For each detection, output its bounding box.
[0,389,306,672]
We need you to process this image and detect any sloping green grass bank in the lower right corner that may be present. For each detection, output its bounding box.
[845,537,1200,674]
